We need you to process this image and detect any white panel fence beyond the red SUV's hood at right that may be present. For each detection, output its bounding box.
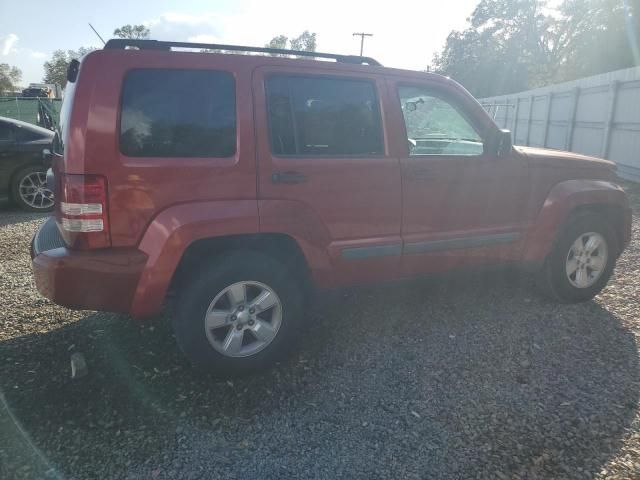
[480,67,640,182]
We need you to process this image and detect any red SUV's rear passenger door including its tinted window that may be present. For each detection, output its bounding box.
[253,67,402,284]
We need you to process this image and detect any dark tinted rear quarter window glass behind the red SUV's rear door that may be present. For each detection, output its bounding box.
[120,69,236,157]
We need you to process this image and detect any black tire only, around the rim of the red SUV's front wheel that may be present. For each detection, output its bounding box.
[548,214,617,303]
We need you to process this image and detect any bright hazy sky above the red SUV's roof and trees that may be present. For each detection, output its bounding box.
[0,0,478,86]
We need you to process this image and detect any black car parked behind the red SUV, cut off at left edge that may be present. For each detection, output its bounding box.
[0,117,54,212]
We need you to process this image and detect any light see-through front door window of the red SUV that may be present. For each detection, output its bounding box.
[398,87,483,155]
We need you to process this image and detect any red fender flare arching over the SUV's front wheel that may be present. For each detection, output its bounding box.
[523,180,629,263]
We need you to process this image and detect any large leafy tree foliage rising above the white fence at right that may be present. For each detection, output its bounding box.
[433,0,640,97]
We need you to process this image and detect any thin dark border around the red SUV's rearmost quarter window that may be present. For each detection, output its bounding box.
[117,67,240,160]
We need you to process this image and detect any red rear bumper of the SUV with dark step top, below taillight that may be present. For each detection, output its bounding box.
[31,217,147,313]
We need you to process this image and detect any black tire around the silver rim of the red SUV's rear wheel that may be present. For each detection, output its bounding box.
[173,252,302,376]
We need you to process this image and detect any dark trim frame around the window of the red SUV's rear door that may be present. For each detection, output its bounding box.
[263,72,387,159]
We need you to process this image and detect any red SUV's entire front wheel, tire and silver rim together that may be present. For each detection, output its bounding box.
[537,213,619,303]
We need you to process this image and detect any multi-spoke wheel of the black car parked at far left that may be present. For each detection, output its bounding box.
[11,165,54,212]
